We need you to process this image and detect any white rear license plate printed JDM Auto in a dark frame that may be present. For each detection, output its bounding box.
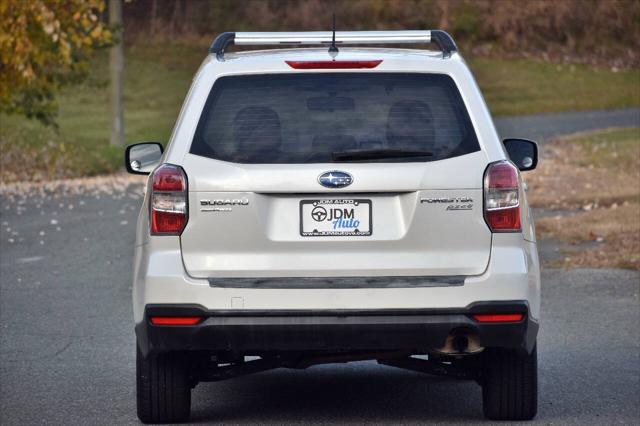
[300,199,372,237]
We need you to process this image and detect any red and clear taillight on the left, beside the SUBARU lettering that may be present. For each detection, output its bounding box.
[149,164,189,235]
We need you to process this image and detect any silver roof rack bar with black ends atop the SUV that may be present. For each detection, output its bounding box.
[209,30,458,61]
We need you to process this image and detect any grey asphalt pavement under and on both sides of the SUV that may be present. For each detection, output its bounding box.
[0,108,640,425]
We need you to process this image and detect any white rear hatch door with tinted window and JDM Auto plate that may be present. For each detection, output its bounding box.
[181,72,491,278]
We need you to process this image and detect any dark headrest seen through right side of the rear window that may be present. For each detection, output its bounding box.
[387,100,436,150]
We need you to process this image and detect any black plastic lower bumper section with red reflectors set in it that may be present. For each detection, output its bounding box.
[136,301,538,356]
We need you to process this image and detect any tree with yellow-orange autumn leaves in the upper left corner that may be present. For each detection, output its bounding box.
[0,0,112,125]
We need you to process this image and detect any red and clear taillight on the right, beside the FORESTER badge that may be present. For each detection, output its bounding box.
[484,161,521,232]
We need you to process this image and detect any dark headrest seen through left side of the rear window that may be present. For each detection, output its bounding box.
[233,106,282,153]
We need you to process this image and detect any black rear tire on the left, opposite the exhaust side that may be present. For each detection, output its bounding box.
[136,349,191,423]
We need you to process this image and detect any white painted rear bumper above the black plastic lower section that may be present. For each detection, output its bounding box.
[133,233,540,324]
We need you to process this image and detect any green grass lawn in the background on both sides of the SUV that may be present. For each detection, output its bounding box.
[0,45,640,182]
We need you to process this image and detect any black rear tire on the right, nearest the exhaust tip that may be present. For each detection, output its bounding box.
[482,347,538,420]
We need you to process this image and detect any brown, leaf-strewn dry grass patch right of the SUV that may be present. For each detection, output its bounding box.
[525,127,640,270]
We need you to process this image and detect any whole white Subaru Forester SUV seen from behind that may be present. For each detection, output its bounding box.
[125,31,540,422]
